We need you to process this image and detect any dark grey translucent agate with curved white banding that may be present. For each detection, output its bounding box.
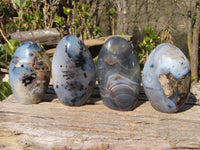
[97,37,140,111]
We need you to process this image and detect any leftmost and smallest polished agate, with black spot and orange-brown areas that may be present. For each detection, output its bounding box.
[9,41,51,104]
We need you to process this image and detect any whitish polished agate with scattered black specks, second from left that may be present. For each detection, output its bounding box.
[52,35,96,106]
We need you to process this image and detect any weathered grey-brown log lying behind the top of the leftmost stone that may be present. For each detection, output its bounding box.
[11,28,60,46]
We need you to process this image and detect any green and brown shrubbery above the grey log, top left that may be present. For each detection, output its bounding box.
[0,0,103,40]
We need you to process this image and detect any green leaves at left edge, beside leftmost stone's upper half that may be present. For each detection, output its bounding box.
[0,40,20,69]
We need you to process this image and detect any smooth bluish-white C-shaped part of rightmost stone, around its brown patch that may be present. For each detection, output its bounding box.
[142,43,190,113]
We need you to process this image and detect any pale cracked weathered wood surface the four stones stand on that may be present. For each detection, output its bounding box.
[0,86,200,150]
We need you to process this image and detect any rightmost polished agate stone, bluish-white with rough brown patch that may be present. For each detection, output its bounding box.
[142,43,191,113]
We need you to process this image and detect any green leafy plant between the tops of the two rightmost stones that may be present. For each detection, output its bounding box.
[137,26,160,69]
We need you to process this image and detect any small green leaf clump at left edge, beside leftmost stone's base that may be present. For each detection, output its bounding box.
[0,82,12,101]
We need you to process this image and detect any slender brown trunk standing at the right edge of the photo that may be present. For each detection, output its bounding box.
[190,2,200,84]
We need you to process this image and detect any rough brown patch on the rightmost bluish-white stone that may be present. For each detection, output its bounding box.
[158,72,191,106]
